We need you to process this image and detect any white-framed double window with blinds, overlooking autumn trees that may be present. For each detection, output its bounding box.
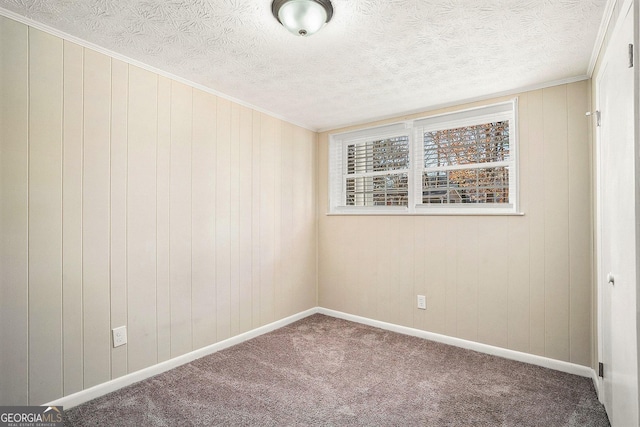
[329,100,517,214]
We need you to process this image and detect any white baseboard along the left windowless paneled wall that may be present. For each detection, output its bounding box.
[43,307,318,409]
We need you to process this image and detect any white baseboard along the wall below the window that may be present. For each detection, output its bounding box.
[318,307,595,378]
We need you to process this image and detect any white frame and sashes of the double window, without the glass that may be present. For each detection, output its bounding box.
[329,98,521,215]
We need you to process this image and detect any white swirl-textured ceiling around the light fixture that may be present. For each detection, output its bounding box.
[0,0,606,130]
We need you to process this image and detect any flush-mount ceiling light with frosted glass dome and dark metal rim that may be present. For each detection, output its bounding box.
[271,0,333,36]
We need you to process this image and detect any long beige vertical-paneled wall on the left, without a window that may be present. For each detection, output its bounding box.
[0,17,317,405]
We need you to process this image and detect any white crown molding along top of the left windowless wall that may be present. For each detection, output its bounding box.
[0,7,317,132]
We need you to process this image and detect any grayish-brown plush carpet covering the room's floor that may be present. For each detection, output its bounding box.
[65,314,609,426]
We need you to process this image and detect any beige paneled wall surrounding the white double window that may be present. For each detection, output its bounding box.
[318,81,592,366]
